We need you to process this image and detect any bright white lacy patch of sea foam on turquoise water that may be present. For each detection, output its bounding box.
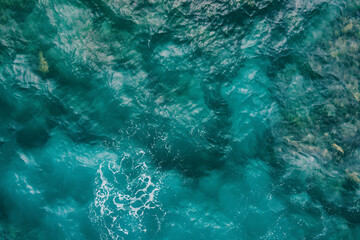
[91,150,165,239]
